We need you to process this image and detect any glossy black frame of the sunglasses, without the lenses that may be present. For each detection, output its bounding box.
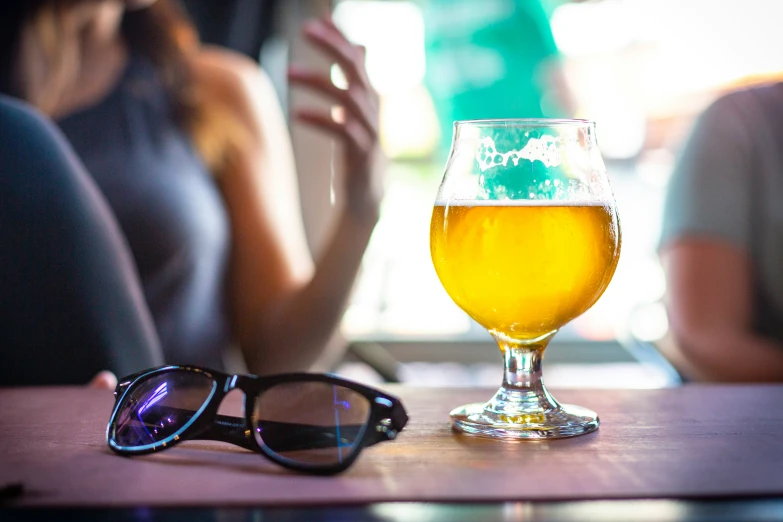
[106,365,408,475]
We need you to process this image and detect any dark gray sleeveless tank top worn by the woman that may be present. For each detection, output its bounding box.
[58,55,231,369]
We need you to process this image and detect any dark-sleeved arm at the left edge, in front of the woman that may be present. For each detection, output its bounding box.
[0,97,163,385]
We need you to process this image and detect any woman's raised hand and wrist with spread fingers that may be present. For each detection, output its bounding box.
[288,18,383,223]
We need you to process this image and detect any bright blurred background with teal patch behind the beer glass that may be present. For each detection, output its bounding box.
[186,0,783,388]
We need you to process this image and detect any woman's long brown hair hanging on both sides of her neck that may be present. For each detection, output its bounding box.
[0,0,245,174]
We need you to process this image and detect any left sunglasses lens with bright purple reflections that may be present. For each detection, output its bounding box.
[109,370,215,449]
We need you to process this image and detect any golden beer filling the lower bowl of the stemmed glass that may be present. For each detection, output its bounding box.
[430,201,620,340]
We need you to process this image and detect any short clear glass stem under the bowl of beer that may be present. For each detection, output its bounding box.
[485,332,560,416]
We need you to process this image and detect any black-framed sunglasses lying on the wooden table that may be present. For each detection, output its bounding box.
[106,366,408,474]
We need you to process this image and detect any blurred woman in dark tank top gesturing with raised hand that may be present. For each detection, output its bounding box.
[0,0,382,373]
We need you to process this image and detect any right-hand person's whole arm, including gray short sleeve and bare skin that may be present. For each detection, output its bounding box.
[660,93,783,381]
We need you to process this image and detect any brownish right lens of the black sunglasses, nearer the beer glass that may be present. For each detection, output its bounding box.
[253,382,370,467]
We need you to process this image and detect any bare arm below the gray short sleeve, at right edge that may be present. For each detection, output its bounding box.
[661,237,783,381]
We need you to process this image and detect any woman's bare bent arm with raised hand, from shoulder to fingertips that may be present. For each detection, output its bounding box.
[194,17,382,374]
